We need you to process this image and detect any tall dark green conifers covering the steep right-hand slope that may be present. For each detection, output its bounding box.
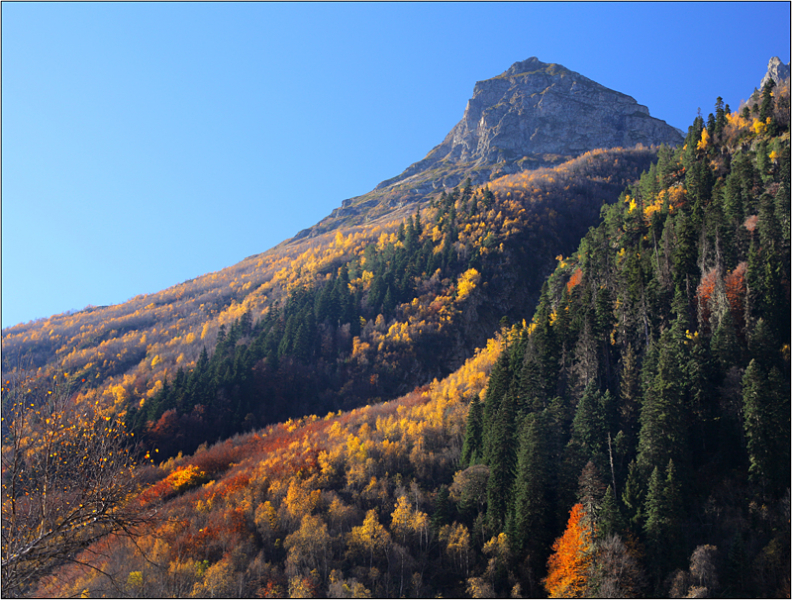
[468,88,790,595]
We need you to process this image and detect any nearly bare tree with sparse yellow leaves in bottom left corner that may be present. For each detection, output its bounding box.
[2,375,149,597]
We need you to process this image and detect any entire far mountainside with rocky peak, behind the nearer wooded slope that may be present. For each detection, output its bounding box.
[2,59,676,453]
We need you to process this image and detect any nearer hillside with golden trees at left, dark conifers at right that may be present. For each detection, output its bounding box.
[23,77,790,598]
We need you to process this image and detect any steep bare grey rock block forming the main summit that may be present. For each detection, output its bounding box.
[388,57,683,185]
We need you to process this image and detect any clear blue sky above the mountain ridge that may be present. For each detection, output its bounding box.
[2,2,790,327]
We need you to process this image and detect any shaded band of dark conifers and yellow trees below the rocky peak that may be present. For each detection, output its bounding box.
[127,149,654,455]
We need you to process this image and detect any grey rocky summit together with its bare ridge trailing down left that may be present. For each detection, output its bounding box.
[297,58,684,239]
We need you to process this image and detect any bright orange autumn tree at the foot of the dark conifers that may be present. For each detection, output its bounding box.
[542,504,593,598]
